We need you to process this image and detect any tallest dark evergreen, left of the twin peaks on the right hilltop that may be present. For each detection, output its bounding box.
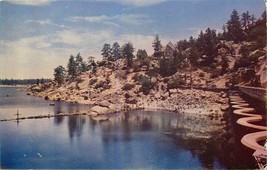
[227,9,243,43]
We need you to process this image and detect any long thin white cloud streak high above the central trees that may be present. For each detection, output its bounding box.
[67,14,152,26]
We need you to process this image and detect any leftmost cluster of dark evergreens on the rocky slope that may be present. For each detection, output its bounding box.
[54,53,92,85]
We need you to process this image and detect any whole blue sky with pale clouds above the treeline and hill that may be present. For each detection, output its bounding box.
[0,0,265,78]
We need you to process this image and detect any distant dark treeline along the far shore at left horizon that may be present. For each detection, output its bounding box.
[0,78,51,85]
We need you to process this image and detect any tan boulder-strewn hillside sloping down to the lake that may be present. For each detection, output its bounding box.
[28,61,232,121]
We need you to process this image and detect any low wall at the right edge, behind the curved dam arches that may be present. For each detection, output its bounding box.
[238,86,266,101]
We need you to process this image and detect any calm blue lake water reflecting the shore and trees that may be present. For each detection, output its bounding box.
[0,87,256,169]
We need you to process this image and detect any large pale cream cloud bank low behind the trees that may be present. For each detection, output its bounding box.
[0,25,174,78]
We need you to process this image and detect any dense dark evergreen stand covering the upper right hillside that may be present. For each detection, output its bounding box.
[152,9,266,76]
